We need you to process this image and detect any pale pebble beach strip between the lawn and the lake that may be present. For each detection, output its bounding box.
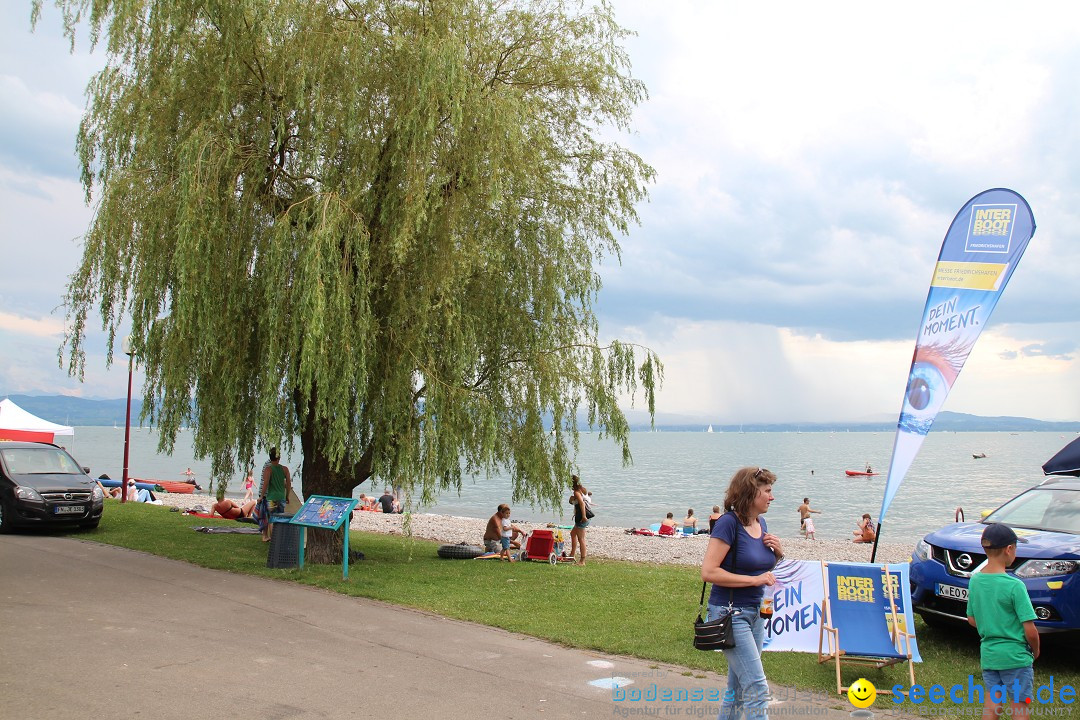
[158,492,912,565]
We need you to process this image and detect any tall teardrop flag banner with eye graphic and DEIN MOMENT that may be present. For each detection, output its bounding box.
[878,188,1035,524]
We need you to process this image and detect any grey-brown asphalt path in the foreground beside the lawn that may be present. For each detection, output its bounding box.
[0,535,881,720]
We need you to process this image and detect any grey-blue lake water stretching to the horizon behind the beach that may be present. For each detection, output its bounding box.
[60,427,1074,543]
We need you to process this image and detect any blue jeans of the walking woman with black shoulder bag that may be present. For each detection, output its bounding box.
[708,604,769,720]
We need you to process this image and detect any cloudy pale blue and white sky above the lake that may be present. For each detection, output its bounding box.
[0,0,1080,423]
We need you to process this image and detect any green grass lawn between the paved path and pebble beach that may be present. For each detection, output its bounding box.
[77,502,1080,709]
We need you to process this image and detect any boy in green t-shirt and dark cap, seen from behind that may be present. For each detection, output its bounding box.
[968,522,1039,720]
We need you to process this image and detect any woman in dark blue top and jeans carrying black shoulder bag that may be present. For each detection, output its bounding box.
[701,467,784,720]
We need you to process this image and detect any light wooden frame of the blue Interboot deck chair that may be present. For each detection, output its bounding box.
[818,562,915,695]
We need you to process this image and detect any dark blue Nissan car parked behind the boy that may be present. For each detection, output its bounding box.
[910,479,1080,633]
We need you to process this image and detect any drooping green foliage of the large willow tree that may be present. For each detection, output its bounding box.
[44,0,660,560]
